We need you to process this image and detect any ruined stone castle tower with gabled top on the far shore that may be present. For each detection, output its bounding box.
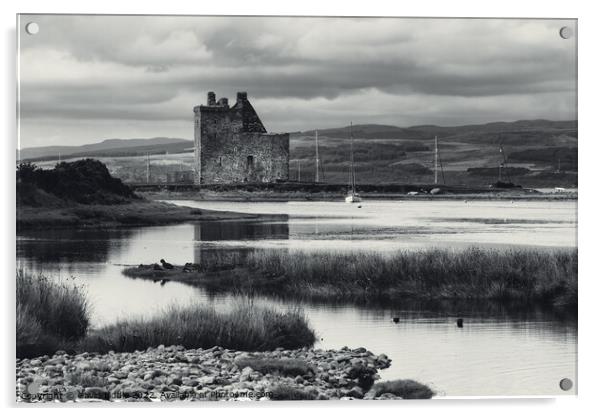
[194,92,289,184]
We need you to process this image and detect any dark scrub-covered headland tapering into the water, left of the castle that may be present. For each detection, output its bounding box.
[17,159,257,229]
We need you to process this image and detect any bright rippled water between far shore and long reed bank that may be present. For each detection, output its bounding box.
[174,201,577,251]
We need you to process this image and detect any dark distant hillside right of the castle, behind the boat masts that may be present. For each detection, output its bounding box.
[290,120,578,187]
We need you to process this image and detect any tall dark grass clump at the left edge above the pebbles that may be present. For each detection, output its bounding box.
[16,270,90,356]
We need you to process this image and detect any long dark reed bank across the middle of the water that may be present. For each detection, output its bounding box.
[124,248,577,307]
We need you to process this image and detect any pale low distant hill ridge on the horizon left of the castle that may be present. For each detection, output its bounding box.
[20,137,193,161]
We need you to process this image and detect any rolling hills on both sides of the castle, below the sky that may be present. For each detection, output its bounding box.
[21,120,578,187]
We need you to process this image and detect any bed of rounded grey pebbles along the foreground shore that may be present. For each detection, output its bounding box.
[17,346,394,402]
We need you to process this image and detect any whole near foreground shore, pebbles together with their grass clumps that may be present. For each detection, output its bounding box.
[15,273,434,403]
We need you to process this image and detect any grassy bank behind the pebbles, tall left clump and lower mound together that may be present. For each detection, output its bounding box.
[16,271,315,357]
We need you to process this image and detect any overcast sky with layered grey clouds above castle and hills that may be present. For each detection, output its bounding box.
[19,16,576,147]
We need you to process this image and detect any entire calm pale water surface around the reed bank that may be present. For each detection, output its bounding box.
[17,201,577,396]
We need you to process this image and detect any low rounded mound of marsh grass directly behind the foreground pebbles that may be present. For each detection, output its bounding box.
[80,301,316,353]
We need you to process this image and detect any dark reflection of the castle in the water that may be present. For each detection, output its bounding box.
[194,215,289,269]
